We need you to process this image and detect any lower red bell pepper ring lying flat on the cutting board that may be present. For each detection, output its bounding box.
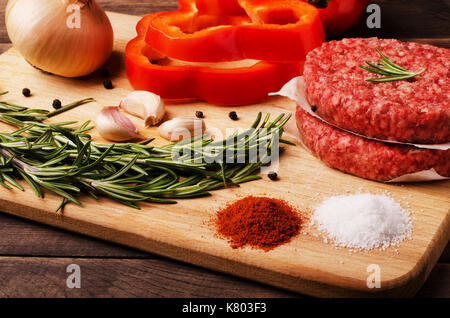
[125,13,303,105]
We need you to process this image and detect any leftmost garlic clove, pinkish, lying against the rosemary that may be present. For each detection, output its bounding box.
[95,106,141,141]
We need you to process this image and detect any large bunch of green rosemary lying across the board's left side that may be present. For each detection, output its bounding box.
[0,92,290,211]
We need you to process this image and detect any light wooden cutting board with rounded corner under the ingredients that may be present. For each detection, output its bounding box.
[0,13,450,296]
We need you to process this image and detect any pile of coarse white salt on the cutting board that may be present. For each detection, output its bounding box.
[311,193,412,250]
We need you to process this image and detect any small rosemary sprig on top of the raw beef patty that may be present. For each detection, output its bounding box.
[359,48,426,83]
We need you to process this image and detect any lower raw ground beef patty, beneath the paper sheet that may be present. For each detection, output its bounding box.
[296,107,450,181]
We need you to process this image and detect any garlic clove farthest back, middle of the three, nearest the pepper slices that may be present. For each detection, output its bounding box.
[119,91,166,127]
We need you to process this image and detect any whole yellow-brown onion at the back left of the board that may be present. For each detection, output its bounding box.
[5,0,113,77]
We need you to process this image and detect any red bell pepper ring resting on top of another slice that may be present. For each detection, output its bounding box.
[145,0,325,62]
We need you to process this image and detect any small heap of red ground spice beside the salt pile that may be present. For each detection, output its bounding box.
[215,196,302,251]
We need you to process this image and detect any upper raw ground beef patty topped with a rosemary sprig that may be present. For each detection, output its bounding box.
[303,38,450,144]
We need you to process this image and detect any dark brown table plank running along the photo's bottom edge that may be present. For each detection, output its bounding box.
[0,257,299,298]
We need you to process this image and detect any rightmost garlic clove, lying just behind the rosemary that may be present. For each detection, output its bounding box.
[158,116,205,142]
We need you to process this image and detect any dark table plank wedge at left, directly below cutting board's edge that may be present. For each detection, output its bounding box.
[0,214,149,258]
